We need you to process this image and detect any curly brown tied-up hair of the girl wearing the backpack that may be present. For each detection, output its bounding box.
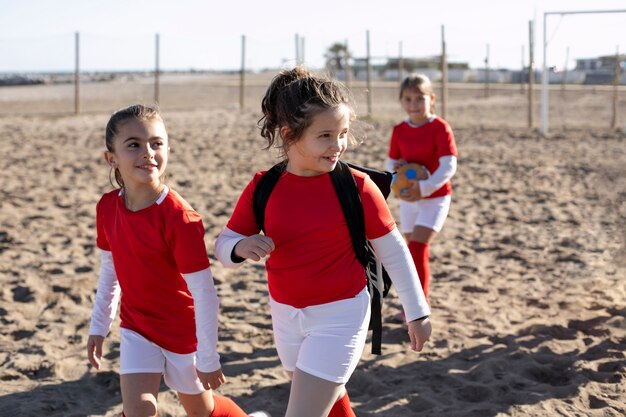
[258,66,355,156]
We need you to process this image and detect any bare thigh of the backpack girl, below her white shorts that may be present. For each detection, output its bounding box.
[285,368,354,417]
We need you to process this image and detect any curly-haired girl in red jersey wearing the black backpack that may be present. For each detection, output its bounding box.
[216,67,431,417]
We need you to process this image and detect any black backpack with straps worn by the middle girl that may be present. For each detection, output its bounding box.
[252,161,393,355]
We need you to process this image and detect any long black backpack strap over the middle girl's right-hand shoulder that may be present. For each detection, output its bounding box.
[330,161,384,355]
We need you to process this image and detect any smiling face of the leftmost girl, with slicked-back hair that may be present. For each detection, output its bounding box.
[104,119,170,189]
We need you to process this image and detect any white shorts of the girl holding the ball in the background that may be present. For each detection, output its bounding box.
[400,195,452,234]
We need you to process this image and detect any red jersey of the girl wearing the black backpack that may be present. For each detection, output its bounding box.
[227,170,395,308]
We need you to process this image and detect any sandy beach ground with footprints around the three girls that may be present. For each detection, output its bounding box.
[0,75,626,417]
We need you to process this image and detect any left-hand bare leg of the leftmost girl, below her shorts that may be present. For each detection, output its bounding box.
[120,373,161,417]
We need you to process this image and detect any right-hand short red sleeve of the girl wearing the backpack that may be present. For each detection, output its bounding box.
[352,170,396,240]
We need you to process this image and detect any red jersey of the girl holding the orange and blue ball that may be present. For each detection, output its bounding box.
[389,117,458,198]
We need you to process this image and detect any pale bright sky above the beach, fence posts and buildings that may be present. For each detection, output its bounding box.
[0,0,626,72]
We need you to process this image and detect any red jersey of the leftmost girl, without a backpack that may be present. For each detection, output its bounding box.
[96,190,210,354]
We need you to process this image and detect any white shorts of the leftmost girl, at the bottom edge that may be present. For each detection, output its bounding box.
[120,328,205,395]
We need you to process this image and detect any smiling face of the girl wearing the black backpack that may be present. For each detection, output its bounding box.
[281,105,350,177]
